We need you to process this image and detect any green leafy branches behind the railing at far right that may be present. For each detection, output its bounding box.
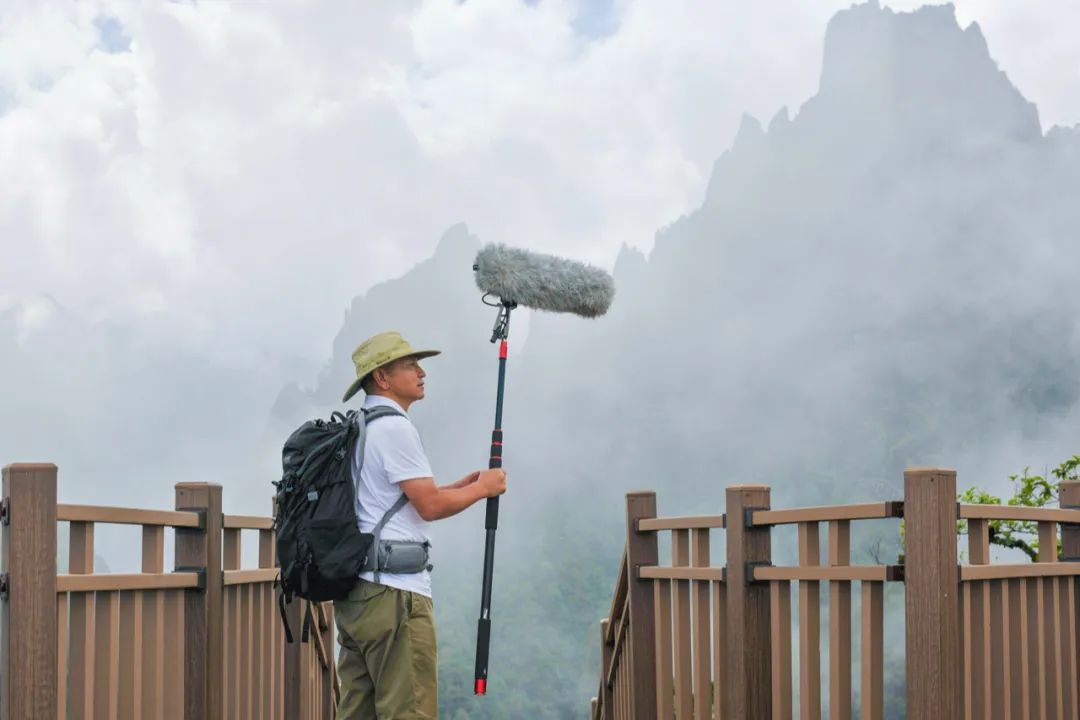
[957,454,1080,561]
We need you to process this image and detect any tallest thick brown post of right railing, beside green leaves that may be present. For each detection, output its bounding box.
[904,467,963,720]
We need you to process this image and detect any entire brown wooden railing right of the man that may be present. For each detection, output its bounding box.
[592,468,1080,720]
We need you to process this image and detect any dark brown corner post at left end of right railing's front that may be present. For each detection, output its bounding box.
[626,492,660,720]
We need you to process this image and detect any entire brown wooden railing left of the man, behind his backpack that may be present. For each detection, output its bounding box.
[0,464,337,720]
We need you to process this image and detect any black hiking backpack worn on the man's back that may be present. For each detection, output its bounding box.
[273,407,401,642]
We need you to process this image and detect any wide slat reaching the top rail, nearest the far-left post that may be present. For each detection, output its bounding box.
[68,522,94,720]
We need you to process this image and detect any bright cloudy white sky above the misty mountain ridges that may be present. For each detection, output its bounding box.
[0,0,1080,371]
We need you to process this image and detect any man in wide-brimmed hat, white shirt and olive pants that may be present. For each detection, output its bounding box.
[334,332,507,720]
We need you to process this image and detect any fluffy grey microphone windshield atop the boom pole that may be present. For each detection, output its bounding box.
[473,244,615,317]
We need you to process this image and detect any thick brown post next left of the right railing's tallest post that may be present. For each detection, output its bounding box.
[725,485,773,720]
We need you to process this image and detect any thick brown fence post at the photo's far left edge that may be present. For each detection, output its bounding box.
[0,464,57,720]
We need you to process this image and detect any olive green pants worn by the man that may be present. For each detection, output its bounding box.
[334,580,438,720]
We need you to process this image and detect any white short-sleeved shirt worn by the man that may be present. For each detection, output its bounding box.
[352,395,434,597]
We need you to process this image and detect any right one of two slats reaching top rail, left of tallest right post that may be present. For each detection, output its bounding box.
[828,520,851,720]
